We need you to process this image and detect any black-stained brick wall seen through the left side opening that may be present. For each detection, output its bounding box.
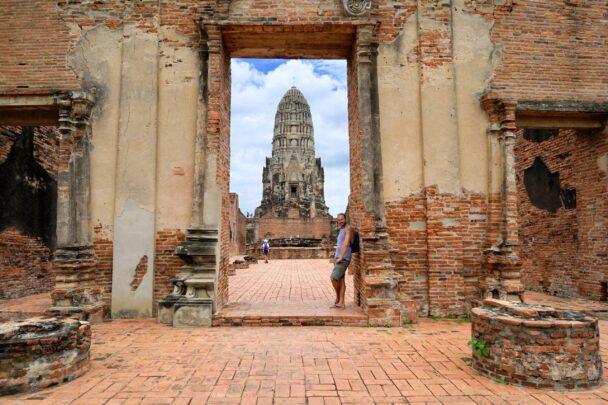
[0,126,60,298]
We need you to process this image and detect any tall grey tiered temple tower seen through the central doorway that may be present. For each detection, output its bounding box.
[247,87,332,247]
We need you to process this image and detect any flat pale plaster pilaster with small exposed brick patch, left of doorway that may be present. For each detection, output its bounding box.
[112,25,158,317]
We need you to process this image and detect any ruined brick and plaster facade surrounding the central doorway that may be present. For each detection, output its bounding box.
[0,0,608,326]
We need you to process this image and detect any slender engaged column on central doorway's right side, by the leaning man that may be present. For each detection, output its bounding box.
[351,25,401,326]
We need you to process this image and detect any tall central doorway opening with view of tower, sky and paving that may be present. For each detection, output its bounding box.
[221,58,361,319]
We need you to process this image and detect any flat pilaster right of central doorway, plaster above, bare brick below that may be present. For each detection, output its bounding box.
[417,0,467,316]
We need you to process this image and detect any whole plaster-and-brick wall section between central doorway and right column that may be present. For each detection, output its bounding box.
[378,0,499,314]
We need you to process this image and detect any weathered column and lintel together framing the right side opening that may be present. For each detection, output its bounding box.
[479,94,608,301]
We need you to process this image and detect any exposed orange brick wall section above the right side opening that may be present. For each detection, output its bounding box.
[486,0,608,101]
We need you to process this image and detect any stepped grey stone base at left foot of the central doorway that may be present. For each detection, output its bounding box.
[158,228,217,328]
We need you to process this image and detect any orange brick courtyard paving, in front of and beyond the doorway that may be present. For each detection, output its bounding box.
[0,260,608,405]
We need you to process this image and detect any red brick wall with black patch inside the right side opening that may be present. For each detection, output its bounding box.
[515,130,608,300]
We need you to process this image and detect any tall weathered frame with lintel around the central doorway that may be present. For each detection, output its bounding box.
[166,21,401,326]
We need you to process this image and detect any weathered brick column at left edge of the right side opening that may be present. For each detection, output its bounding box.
[480,96,524,301]
